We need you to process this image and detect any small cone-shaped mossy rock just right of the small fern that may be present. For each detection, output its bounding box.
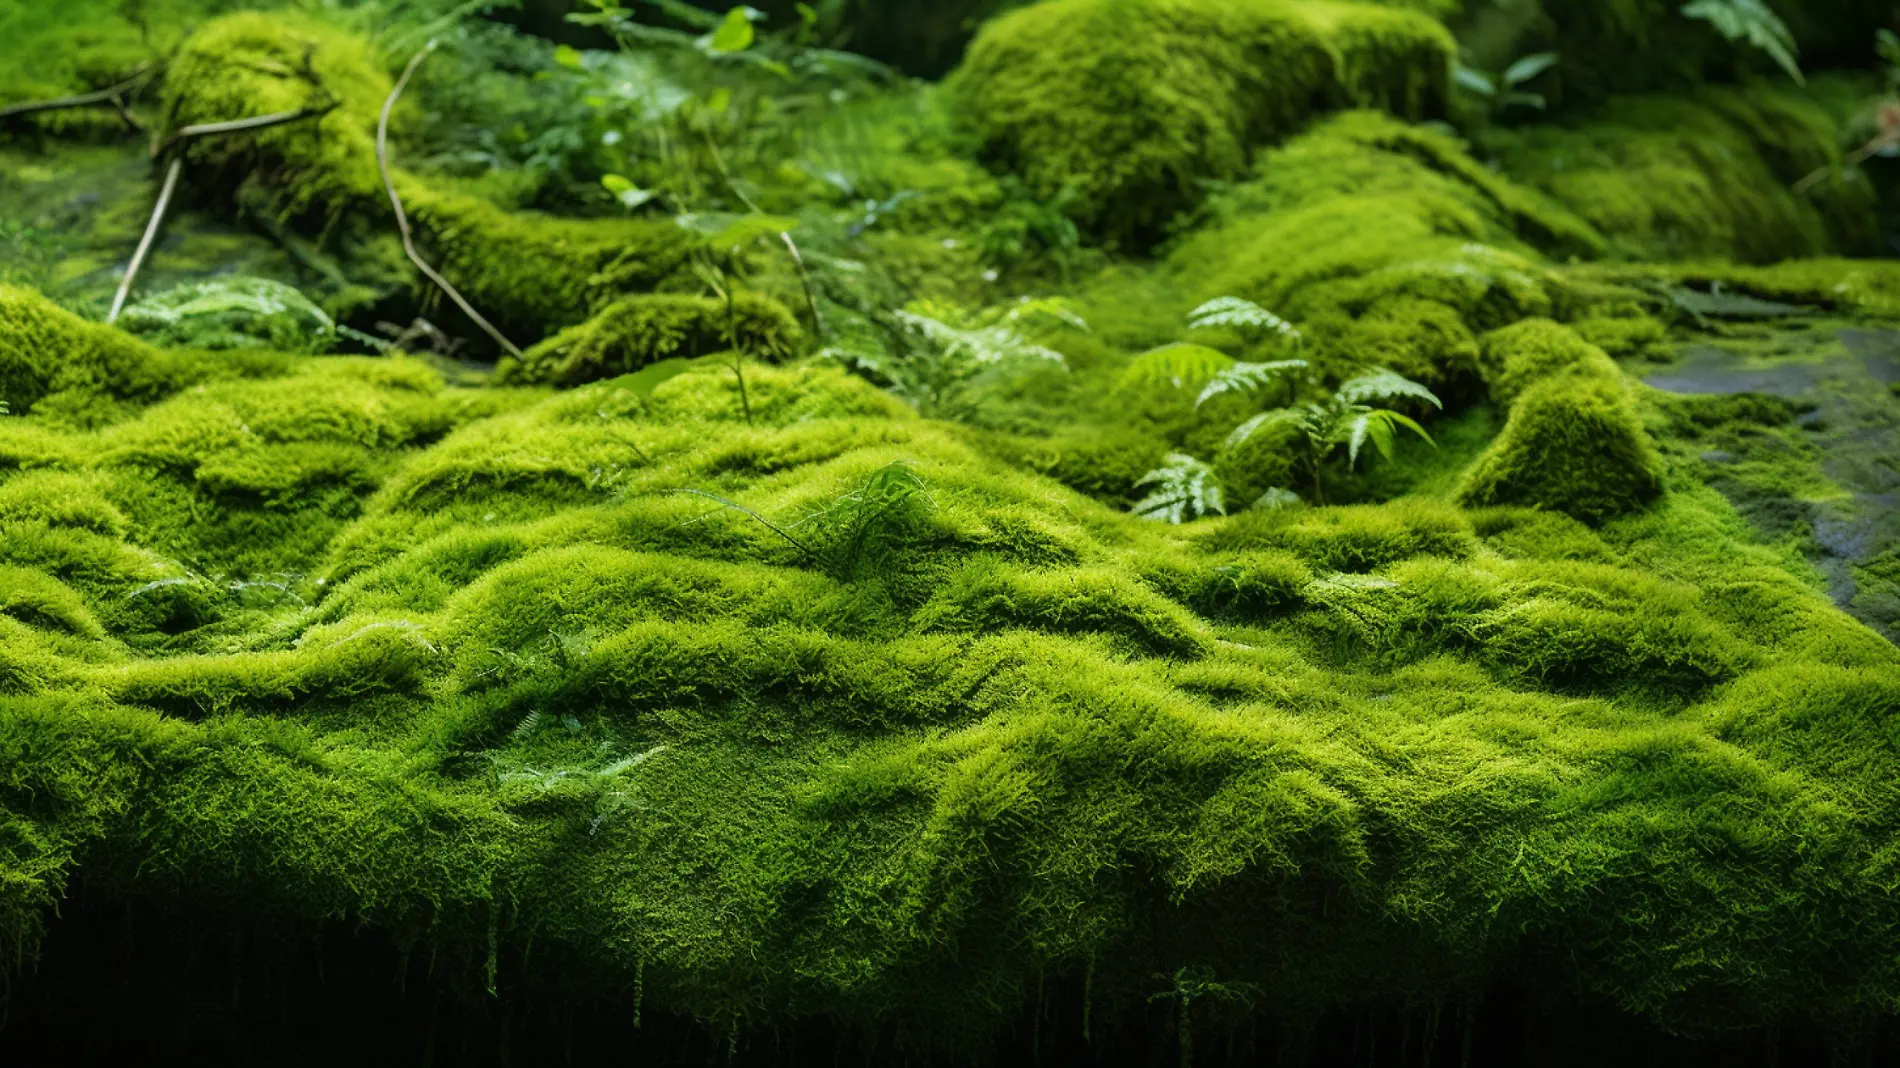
[1459,374,1663,523]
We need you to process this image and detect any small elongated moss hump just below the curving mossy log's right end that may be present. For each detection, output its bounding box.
[496,293,800,386]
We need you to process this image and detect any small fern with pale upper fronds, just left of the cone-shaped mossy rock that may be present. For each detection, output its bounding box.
[1224,369,1444,505]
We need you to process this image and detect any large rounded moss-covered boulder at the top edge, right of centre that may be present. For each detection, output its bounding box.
[952,0,1454,241]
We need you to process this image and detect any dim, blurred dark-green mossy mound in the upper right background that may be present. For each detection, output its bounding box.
[1484,87,1879,262]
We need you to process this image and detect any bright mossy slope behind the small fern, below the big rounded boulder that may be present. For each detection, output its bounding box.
[1165,112,1600,385]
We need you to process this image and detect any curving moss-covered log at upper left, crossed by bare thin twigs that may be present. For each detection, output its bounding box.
[163,13,697,344]
